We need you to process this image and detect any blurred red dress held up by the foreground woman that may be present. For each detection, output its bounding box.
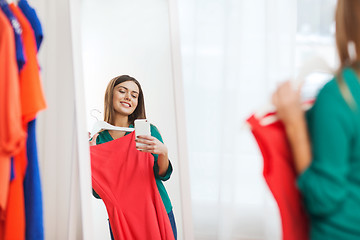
[247,116,309,240]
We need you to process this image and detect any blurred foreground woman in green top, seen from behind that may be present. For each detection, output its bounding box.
[273,0,360,240]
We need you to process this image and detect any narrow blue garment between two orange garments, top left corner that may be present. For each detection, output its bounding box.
[0,0,26,71]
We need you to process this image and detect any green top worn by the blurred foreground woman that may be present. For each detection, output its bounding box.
[297,68,360,240]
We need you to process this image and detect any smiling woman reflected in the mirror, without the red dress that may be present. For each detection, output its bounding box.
[90,75,177,239]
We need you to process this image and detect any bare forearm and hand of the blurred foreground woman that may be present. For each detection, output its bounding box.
[272,81,312,174]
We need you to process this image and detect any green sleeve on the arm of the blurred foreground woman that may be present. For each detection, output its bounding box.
[297,81,352,217]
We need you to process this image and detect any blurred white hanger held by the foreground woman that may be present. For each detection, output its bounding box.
[254,56,333,126]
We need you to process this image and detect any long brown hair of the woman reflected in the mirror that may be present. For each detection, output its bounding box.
[104,75,146,124]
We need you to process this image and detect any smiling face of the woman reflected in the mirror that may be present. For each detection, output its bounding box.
[113,81,139,116]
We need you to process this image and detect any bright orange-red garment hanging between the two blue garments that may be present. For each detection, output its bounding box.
[4,4,46,240]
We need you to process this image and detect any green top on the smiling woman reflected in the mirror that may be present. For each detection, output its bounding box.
[93,124,173,213]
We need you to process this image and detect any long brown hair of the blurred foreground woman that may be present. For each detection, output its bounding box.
[335,0,360,106]
